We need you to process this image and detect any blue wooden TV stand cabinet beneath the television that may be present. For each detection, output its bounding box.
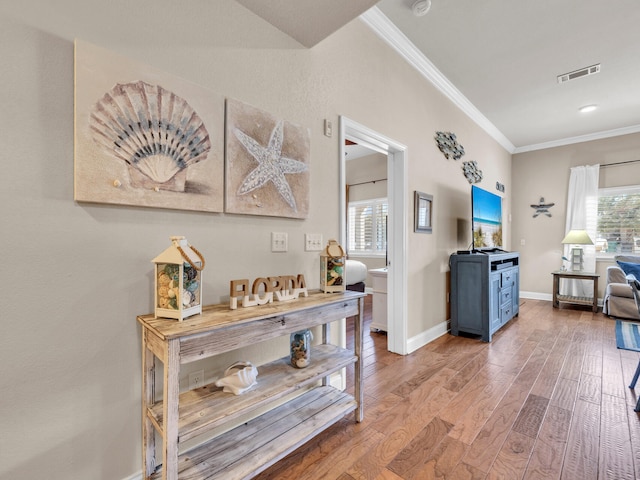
[449,249,520,342]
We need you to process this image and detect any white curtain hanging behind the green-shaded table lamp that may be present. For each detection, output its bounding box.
[561,165,600,297]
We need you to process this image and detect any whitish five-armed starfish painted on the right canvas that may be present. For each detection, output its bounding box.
[233,121,307,212]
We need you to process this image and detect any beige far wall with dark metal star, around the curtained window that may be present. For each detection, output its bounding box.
[512,134,640,298]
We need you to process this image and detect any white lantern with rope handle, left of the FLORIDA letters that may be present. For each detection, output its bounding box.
[152,236,204,321]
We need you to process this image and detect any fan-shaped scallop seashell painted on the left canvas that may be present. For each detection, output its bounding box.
[89,81,211,192]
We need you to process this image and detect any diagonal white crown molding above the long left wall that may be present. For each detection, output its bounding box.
[359,7,516,153]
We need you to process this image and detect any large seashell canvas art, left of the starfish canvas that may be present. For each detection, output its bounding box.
[74,40,224,212]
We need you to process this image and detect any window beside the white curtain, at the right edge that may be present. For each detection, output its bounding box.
[595,185,640,256]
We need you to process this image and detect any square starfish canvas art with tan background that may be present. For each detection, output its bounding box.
[225,99,310,218]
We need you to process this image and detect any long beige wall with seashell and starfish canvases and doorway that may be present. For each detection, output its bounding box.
[0,0,510,480]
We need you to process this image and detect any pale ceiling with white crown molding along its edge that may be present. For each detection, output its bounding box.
[238,0,640,153]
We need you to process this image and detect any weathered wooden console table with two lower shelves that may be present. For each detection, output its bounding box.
[138,292,365,480]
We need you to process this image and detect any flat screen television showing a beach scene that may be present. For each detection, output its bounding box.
[471,185,503,250]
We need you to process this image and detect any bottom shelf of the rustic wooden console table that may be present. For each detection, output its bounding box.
[150,387,358,480]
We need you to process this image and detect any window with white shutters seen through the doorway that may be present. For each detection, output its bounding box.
[347,198,389,256]
